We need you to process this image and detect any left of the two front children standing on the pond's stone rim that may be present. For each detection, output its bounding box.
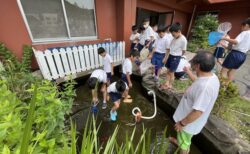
[149,26,170,81]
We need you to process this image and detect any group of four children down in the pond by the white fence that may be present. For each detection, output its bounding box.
[88,47,140,121]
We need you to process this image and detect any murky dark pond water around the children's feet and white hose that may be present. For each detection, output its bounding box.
[73,77,201,154]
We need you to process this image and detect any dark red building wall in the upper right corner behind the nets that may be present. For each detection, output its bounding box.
[197,0,250,38]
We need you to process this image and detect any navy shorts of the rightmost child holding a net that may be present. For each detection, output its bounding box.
[222,50,247,69]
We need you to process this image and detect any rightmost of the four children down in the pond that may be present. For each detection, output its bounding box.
[121,50,140,102]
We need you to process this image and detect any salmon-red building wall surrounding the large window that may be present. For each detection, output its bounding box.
[0,0,118,59]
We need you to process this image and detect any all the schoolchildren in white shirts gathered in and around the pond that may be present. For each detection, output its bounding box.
[88,18,250,121]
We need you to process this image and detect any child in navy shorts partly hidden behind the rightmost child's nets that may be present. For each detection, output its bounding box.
[214,31,230,65]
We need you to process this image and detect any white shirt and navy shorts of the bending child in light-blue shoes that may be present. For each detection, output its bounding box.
[107,82,128,103]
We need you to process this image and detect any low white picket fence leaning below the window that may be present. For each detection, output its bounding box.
[33,41,125,80]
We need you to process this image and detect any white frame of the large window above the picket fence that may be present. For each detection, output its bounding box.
[17,0,98,43]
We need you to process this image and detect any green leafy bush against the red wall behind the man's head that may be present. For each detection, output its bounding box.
[188,14,219,52]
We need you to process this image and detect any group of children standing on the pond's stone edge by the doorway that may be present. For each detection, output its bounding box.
[130,19,190,89]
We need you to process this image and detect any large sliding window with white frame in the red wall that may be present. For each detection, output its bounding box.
[19,0,97,42]
